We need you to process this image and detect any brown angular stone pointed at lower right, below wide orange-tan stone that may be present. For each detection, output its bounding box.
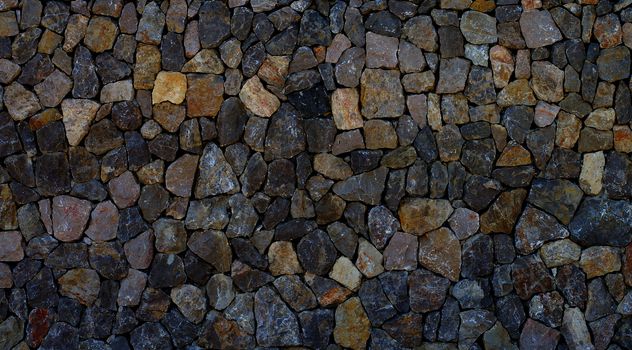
[419,227,461,282]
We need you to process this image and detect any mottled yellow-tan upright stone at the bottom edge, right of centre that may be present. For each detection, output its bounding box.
[334,297,371,350]
